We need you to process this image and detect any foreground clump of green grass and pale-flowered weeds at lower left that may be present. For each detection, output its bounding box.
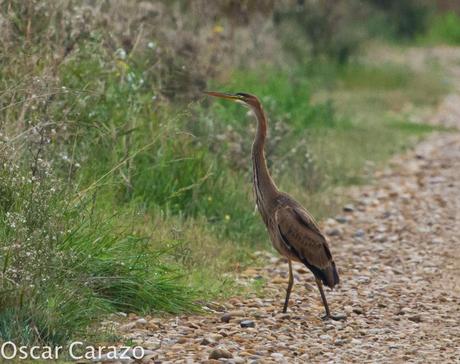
[0,147,194,344]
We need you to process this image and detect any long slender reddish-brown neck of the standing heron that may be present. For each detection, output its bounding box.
[252,106,278,212]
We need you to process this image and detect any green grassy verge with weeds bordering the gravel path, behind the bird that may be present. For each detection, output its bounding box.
[0,1,452,344]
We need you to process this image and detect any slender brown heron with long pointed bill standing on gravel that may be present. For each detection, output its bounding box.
[203,91,345,320]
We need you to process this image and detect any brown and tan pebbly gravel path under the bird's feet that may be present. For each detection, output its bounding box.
[111,49,460,363]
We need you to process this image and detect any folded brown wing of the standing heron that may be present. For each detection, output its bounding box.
[275,206,332,269]
